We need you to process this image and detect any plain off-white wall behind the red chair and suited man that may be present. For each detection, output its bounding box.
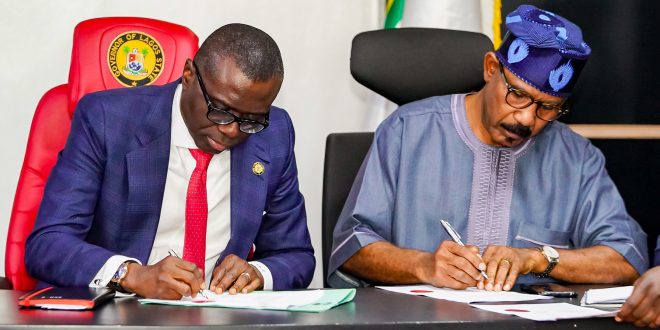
[0,0,384,287]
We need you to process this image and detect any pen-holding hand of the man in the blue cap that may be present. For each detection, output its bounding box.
[418,241,486,289]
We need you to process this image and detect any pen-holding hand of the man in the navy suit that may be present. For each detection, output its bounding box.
[121,256,205,299]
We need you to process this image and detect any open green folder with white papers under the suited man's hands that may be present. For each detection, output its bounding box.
[139,289,355,313]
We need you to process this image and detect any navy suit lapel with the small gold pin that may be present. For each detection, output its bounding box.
[218,136,272,262]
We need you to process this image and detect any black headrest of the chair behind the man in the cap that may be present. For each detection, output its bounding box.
[351,28,493,105]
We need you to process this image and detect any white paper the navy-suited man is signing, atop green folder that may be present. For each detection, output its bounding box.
[140,290,323,309]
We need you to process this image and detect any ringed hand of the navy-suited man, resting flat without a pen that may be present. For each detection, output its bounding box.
[210,254,264,294]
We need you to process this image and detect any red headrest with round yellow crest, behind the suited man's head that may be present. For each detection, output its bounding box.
[68,17,199,114]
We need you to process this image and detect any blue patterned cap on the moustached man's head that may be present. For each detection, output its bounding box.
[495,5,591,97]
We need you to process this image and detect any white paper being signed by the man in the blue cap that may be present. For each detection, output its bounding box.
[377,285,552,304]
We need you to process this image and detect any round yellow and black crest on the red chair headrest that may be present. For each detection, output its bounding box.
[108,31,165,87]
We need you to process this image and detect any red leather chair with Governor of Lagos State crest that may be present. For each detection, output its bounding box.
[5,17,199,290]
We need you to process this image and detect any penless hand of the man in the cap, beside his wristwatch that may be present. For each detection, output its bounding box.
[477,245,540,291]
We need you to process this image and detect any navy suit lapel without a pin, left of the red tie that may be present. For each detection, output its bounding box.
[122,82,178,264]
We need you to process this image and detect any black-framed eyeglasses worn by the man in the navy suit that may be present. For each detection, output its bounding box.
[192,61,270,134]
